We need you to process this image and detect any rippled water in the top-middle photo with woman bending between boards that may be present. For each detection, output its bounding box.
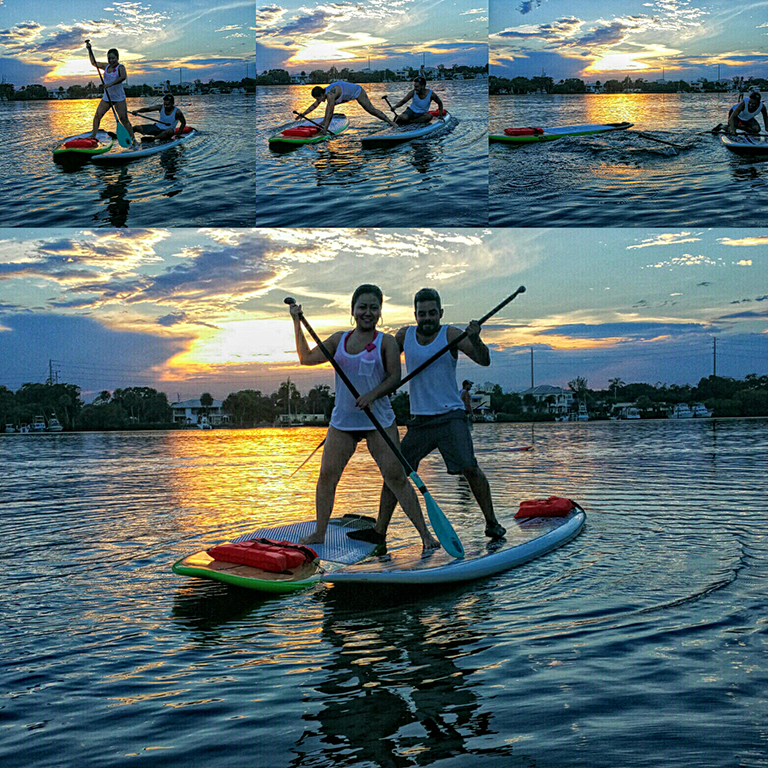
[256,80,488,227]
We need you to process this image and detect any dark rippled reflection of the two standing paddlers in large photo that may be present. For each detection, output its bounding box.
[292,587,494,766]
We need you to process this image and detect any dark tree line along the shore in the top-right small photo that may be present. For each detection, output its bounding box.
[488,75,768,96]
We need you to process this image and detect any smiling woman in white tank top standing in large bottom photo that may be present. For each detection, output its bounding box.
[291,284,440,551]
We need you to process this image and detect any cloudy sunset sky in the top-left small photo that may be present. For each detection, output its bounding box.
[0,0,255,88]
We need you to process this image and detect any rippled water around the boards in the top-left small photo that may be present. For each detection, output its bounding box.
[0,95,255,227]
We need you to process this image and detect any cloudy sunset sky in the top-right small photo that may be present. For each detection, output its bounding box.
[489,0,768,82]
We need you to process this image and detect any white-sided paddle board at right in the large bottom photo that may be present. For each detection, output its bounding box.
[320,507,586,586]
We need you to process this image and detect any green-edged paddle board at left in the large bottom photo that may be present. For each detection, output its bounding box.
[173,515,377,593]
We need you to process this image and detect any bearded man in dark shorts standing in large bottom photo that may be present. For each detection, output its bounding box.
[347,288,507,543]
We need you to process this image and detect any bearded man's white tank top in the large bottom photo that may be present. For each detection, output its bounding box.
[403,325,464,416]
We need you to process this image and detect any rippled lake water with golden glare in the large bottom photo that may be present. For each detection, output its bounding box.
[0,419,768,768]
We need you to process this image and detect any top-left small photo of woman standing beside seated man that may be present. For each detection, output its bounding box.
[0,0,256,228]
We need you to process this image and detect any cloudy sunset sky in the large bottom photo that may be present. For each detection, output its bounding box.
[0,229,768,399]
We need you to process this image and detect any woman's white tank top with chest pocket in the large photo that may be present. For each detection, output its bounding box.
[331,331,395,432]
